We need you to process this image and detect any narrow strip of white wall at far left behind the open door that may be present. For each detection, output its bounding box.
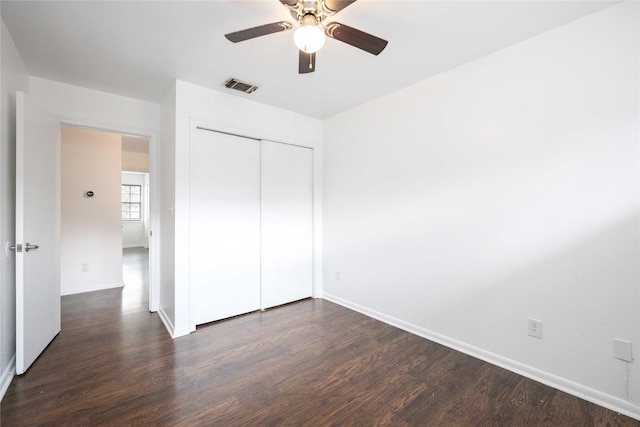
[0,15,29,399]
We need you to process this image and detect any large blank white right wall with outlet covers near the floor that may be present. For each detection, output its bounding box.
[323,2,640,417]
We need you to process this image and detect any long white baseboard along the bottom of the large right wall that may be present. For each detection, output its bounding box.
[323,293,640,420]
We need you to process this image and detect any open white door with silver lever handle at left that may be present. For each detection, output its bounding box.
[15,92,60,375]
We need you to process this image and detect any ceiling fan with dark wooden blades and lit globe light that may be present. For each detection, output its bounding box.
[225,0,388,74]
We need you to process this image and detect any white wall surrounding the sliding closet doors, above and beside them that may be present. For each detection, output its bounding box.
[169,81,322,336]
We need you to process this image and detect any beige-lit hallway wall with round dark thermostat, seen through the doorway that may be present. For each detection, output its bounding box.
[60,126,124,295]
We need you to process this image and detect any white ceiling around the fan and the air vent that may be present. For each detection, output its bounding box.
[1,0,615,118]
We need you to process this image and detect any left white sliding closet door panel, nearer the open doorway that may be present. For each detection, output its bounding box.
[189,130,260,325]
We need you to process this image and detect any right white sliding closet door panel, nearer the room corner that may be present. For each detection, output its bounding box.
[262,141,313,308]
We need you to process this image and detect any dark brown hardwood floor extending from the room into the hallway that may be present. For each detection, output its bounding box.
[1,251,640,426]
